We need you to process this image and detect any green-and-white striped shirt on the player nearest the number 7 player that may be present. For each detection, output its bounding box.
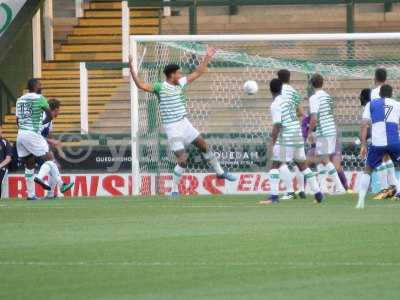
[310,90,336,137]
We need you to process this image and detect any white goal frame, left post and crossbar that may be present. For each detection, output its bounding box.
[129,32,400,196]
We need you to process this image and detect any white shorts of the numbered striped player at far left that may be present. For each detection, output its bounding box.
[16,130,49,158]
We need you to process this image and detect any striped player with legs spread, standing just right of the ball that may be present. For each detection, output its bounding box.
[260,79,323,204]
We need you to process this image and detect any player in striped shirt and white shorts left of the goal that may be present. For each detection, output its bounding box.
[16,78,73,200]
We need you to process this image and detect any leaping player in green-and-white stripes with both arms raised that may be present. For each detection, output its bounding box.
[129,47,236,196]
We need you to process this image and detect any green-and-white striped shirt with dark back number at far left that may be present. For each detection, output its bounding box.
[15,93,49,133]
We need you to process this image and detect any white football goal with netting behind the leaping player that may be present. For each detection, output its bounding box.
[130,33,400,194]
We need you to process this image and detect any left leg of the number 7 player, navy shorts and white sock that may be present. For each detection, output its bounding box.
[356,146,385,208]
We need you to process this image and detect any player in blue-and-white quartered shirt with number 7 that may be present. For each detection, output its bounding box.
[357,84,400,208]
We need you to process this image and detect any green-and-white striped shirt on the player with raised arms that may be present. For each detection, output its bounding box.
[153,77,187,124]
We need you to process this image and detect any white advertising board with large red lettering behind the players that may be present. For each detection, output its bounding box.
[3,171,366,198]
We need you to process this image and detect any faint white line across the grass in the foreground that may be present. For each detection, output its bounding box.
[0,261,400,268]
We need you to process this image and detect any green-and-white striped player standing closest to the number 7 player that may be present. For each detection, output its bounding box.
[307,74,345,193]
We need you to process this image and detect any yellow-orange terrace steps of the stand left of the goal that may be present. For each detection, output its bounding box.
[3,1,160,140]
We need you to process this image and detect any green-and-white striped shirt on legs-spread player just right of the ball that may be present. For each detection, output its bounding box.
[271,95,304,147]
